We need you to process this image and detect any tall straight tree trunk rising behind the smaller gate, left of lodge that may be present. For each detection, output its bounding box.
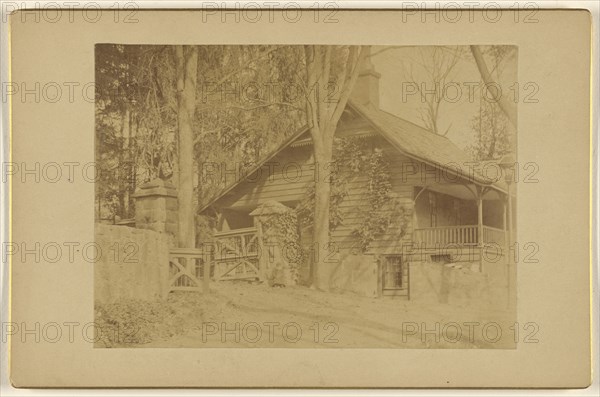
[175,45,198,247]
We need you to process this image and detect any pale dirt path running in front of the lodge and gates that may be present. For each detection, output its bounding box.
[140,282,514,348]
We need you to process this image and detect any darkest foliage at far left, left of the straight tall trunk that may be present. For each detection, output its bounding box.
[95,44,175,217]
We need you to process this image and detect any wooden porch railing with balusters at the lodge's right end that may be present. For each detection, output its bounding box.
[414,225,504,247]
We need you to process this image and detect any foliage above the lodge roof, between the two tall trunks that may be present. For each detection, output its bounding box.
[195,46,305,207]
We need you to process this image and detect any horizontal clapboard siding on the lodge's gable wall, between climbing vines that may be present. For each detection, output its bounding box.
[206,137,460,253]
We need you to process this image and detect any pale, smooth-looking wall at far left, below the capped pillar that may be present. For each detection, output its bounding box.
[94,224,169,303]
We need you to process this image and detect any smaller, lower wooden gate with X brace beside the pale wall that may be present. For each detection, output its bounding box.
[167,248,210,293]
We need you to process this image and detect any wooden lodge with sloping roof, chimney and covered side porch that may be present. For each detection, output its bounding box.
[201,55,511,296]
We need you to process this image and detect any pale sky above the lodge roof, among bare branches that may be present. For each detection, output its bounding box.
[371,46,517,149]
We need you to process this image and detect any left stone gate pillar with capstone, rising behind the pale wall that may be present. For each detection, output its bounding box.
[133,178,178,244]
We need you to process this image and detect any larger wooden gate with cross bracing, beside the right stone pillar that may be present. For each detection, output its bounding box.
[214,227,260,280]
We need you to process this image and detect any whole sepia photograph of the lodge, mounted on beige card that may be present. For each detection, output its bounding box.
[94,43,520,349]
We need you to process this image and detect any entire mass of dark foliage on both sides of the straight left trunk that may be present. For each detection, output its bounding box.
[95,44,305,223]
